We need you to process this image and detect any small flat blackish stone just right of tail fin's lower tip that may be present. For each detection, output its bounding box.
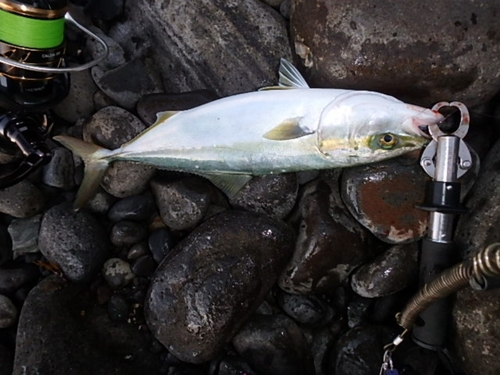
[108,194,156,223]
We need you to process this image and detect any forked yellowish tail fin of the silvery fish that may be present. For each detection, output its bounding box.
[53,135,111,210]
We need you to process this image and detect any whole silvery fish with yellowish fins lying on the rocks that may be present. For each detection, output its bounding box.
[53,59,443,209]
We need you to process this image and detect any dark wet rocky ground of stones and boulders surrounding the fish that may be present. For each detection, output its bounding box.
[0,0,500,375]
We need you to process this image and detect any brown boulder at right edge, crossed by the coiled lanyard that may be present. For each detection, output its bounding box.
[453,137,500,375]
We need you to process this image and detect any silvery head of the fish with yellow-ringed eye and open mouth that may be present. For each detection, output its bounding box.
[317,91,443,166]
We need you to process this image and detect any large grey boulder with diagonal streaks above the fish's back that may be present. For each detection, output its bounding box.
[109,0,291,96]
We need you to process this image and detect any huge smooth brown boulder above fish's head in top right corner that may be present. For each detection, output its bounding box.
[290,0,500,106]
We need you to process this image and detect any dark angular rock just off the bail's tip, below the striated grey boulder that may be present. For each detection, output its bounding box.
[92,59,163,110]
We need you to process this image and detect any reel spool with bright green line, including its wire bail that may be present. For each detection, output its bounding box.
[0,0,108,110]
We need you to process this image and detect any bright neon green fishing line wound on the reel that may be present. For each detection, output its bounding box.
[0,9,64,49]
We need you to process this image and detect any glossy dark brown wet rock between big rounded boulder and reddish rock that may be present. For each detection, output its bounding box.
[279,181,372,294]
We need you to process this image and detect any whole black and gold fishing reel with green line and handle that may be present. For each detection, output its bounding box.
[0,0,108,189]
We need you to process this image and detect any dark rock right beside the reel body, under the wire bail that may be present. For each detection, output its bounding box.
[54,70,99,123]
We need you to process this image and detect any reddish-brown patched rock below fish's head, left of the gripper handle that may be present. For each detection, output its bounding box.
[341,155,429,244]
